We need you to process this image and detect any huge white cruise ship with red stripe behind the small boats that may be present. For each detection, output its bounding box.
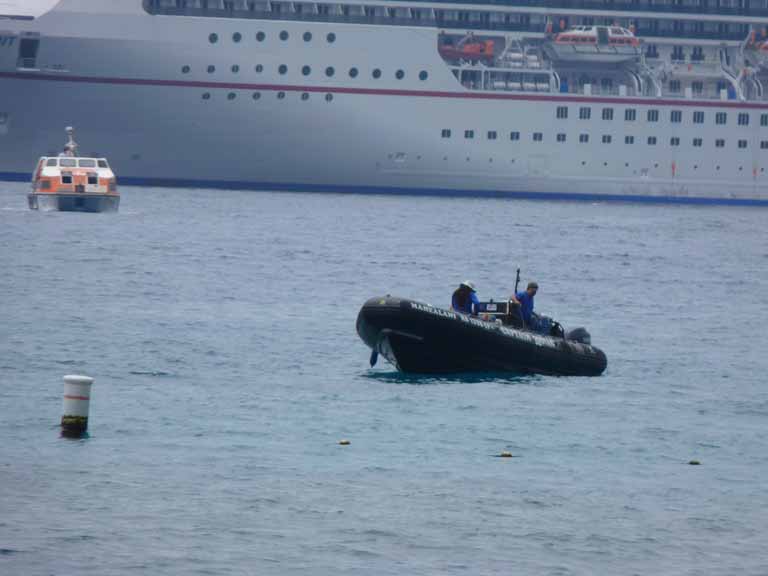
[0,0,768,206]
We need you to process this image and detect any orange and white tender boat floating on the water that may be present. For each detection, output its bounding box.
[27,128,120,212]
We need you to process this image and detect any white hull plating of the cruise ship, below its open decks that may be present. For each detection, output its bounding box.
[0,0,768,204]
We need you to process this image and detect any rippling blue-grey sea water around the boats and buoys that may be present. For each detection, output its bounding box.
[0,183,768,576]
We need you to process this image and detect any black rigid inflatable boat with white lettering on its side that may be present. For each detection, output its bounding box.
[357,296,607,376]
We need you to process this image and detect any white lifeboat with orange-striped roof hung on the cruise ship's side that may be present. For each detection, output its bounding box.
[544,26,641,64]
